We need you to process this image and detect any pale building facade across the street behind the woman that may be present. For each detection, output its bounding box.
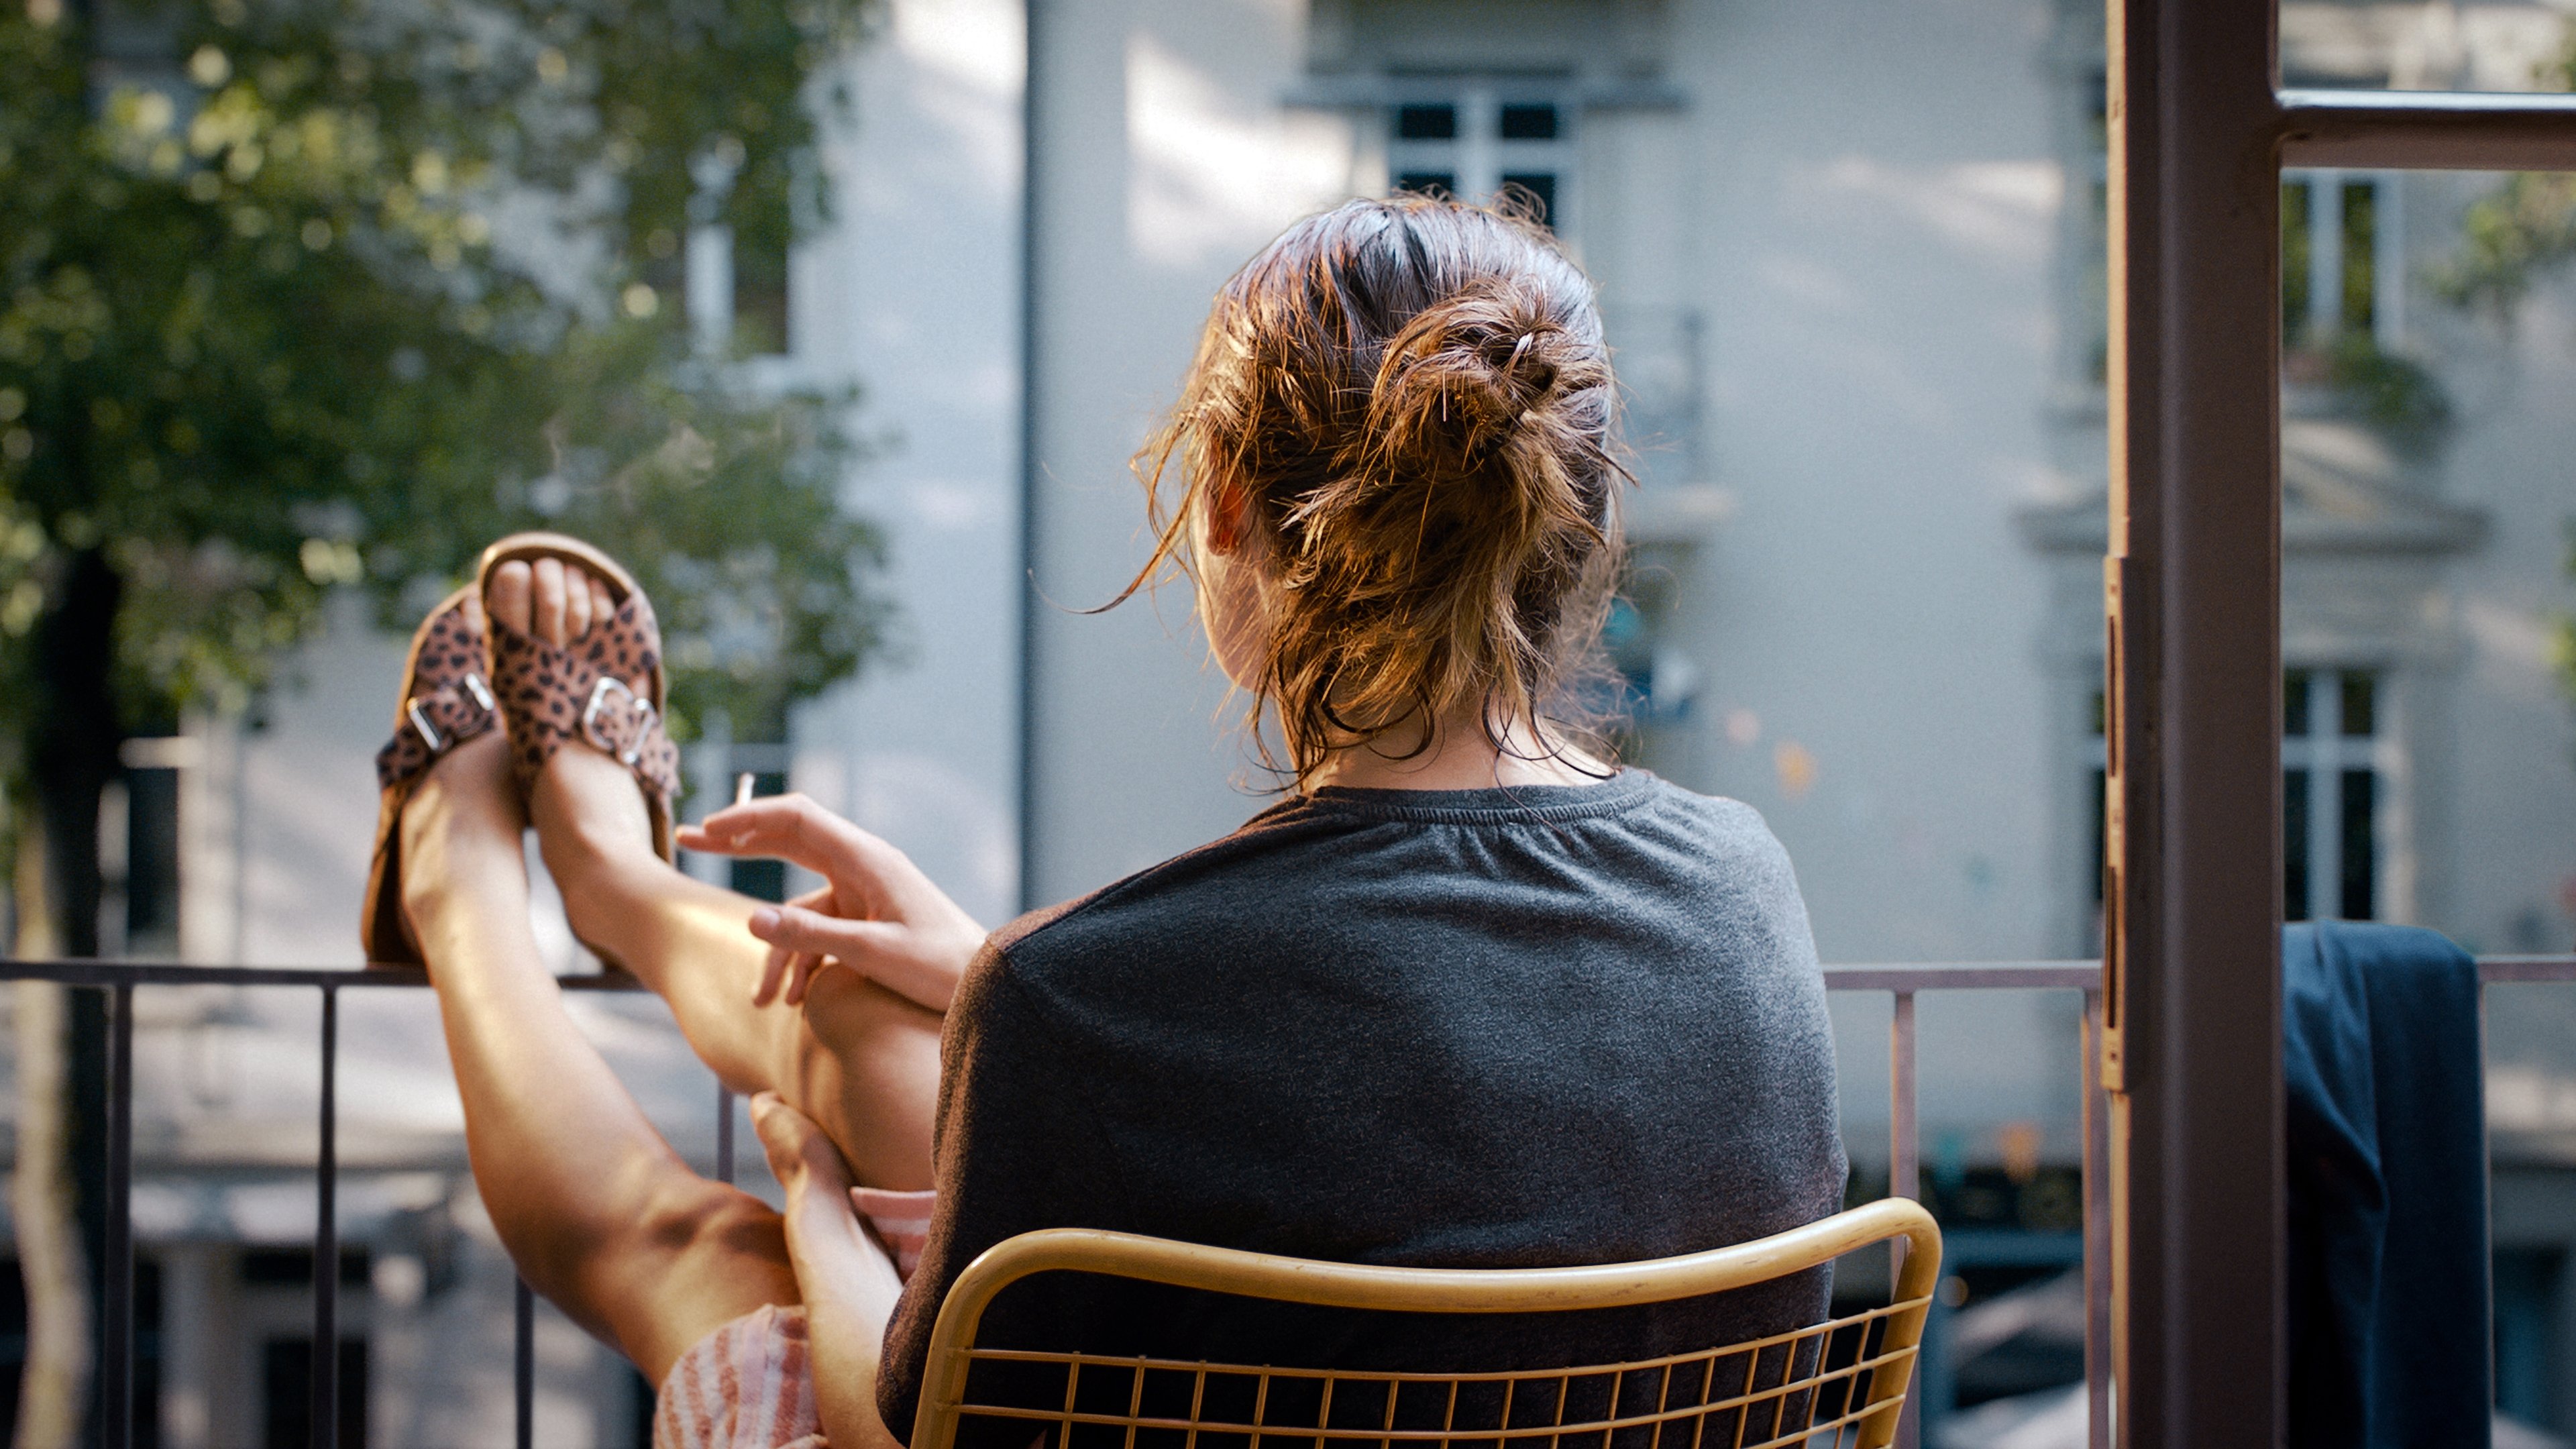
[130,0,2576,1415]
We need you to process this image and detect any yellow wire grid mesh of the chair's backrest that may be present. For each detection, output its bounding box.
[956,1297,1929,1449]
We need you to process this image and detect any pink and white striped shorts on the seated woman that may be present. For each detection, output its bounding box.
[652,1189,938,1449]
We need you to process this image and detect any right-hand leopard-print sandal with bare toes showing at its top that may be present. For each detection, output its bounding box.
[474,534,680,861]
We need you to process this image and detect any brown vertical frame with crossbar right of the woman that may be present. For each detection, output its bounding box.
[2097,0,2576,1449]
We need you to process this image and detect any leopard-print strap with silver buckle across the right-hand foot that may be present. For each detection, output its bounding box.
[492,593,680,807]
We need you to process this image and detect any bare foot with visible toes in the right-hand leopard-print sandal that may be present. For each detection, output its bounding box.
[490,559,657,912]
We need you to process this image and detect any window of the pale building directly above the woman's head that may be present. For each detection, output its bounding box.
[1386,83,1574,229]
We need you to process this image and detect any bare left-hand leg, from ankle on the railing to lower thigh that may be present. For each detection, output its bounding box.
[402,735,798,1382]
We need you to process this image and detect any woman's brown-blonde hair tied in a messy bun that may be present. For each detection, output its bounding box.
[1120,196,1625,784]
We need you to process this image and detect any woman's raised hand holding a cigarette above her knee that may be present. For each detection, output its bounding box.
[680,794,987,1011]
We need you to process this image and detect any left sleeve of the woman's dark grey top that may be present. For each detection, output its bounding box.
[876,947,1110,1444]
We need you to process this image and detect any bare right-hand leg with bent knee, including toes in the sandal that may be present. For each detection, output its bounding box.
[490,554,941,1189]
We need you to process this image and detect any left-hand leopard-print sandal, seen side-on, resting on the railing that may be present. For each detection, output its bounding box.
[358,588,500,967]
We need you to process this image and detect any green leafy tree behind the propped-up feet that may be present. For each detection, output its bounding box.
[0,0,883,1423]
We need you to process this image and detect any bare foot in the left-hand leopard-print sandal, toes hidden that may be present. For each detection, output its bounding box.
[402,733,528,957]
